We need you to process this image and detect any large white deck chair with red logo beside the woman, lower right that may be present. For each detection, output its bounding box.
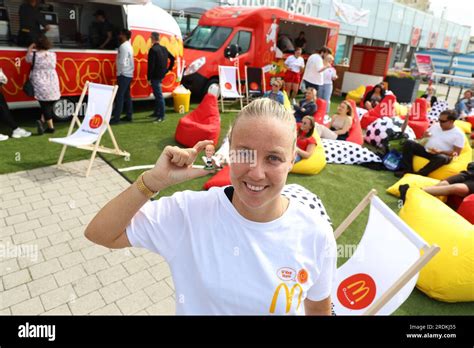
[331,190,440,315]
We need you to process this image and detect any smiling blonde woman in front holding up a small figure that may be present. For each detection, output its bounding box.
[85,98,336,315]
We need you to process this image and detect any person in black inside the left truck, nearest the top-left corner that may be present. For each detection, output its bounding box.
[18,0,49,47]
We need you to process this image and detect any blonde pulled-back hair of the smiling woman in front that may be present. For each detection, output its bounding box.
[229,98,296,151]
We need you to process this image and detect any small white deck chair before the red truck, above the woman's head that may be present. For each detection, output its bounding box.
[219,65,244,112]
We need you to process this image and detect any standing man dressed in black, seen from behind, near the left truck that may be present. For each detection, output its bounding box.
[147,32,174,122]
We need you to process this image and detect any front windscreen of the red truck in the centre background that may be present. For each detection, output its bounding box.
[184,26,232,51]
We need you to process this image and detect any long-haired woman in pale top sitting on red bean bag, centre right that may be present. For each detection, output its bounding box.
[316,100,353,140]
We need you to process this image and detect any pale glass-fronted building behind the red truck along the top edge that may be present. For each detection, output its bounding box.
[152,0,471,67]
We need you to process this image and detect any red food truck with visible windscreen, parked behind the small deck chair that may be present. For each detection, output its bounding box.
[182,6,339,95]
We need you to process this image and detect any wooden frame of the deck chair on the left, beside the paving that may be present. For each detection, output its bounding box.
[51,81,130,177]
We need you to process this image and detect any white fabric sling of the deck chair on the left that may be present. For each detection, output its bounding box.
[49,83,114,147]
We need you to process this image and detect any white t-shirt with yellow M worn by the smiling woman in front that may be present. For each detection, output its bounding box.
[126,188,337,315]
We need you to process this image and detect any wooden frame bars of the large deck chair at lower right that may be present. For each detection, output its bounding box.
[334,190,440,315]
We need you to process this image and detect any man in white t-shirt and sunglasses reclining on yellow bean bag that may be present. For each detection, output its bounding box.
[395,110,466,177]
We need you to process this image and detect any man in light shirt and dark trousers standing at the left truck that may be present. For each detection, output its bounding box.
[110,29,135,124]
